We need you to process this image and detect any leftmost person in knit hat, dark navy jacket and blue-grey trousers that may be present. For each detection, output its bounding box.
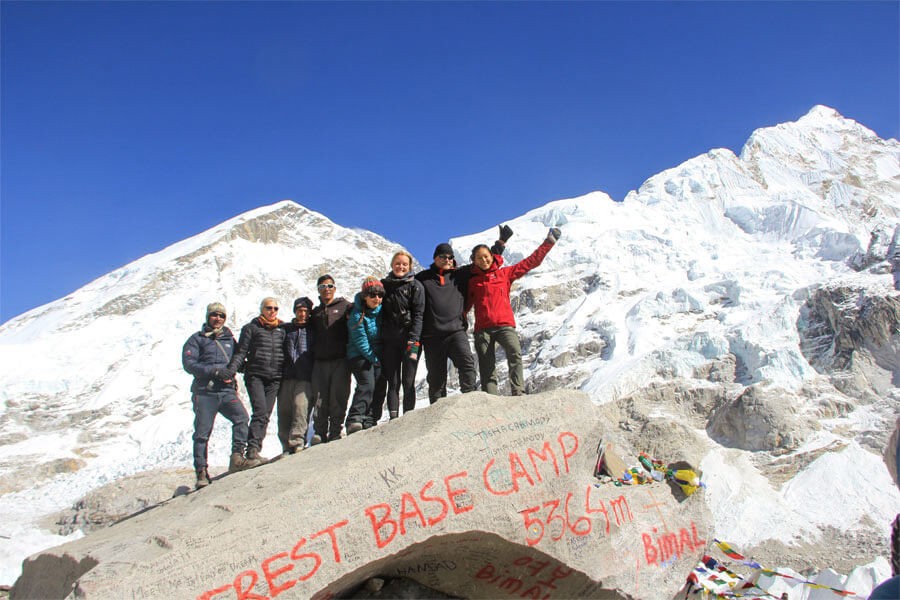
[181,302,259,489]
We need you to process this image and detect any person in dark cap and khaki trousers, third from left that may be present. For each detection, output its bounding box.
[278,296,315,454]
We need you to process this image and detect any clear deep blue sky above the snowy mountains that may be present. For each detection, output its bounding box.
[0,0,900,322]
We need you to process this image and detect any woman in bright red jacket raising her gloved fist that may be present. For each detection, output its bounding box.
[466,227,562,396]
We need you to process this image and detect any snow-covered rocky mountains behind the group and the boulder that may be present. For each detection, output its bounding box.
[0,107,900,583]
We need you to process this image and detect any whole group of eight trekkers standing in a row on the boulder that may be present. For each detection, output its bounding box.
[182,225,561,488]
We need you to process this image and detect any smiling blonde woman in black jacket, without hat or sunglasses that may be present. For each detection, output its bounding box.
[370,250,425,424]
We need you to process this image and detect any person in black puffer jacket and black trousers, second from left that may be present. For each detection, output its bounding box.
[228,298,285,460]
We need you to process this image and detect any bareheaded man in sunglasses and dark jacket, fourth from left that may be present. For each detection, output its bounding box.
[310,273,353,444]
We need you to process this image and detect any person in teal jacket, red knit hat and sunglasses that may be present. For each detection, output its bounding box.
[346,277,384,435]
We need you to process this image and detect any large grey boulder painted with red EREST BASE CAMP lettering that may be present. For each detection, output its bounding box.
[12,390,711,600]
